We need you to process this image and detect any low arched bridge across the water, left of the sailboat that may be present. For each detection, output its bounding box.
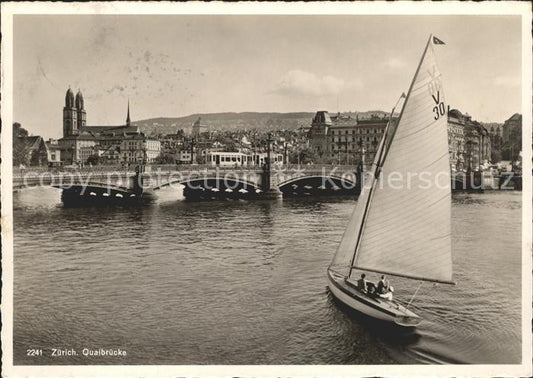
[13,165,359,202]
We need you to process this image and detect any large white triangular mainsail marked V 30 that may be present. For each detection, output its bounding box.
[354,38,452,282]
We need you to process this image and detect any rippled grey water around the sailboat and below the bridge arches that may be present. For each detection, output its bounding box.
[14,188,521,365]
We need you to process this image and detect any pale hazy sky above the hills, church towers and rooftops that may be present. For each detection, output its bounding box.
[13,15,522,138]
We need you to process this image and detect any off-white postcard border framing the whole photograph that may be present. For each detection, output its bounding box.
[1,2,533,377]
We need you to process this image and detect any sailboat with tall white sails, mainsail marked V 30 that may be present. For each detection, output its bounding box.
[328,35,454,327]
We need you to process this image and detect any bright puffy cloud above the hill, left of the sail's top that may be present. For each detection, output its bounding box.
[272,70,346,97]
